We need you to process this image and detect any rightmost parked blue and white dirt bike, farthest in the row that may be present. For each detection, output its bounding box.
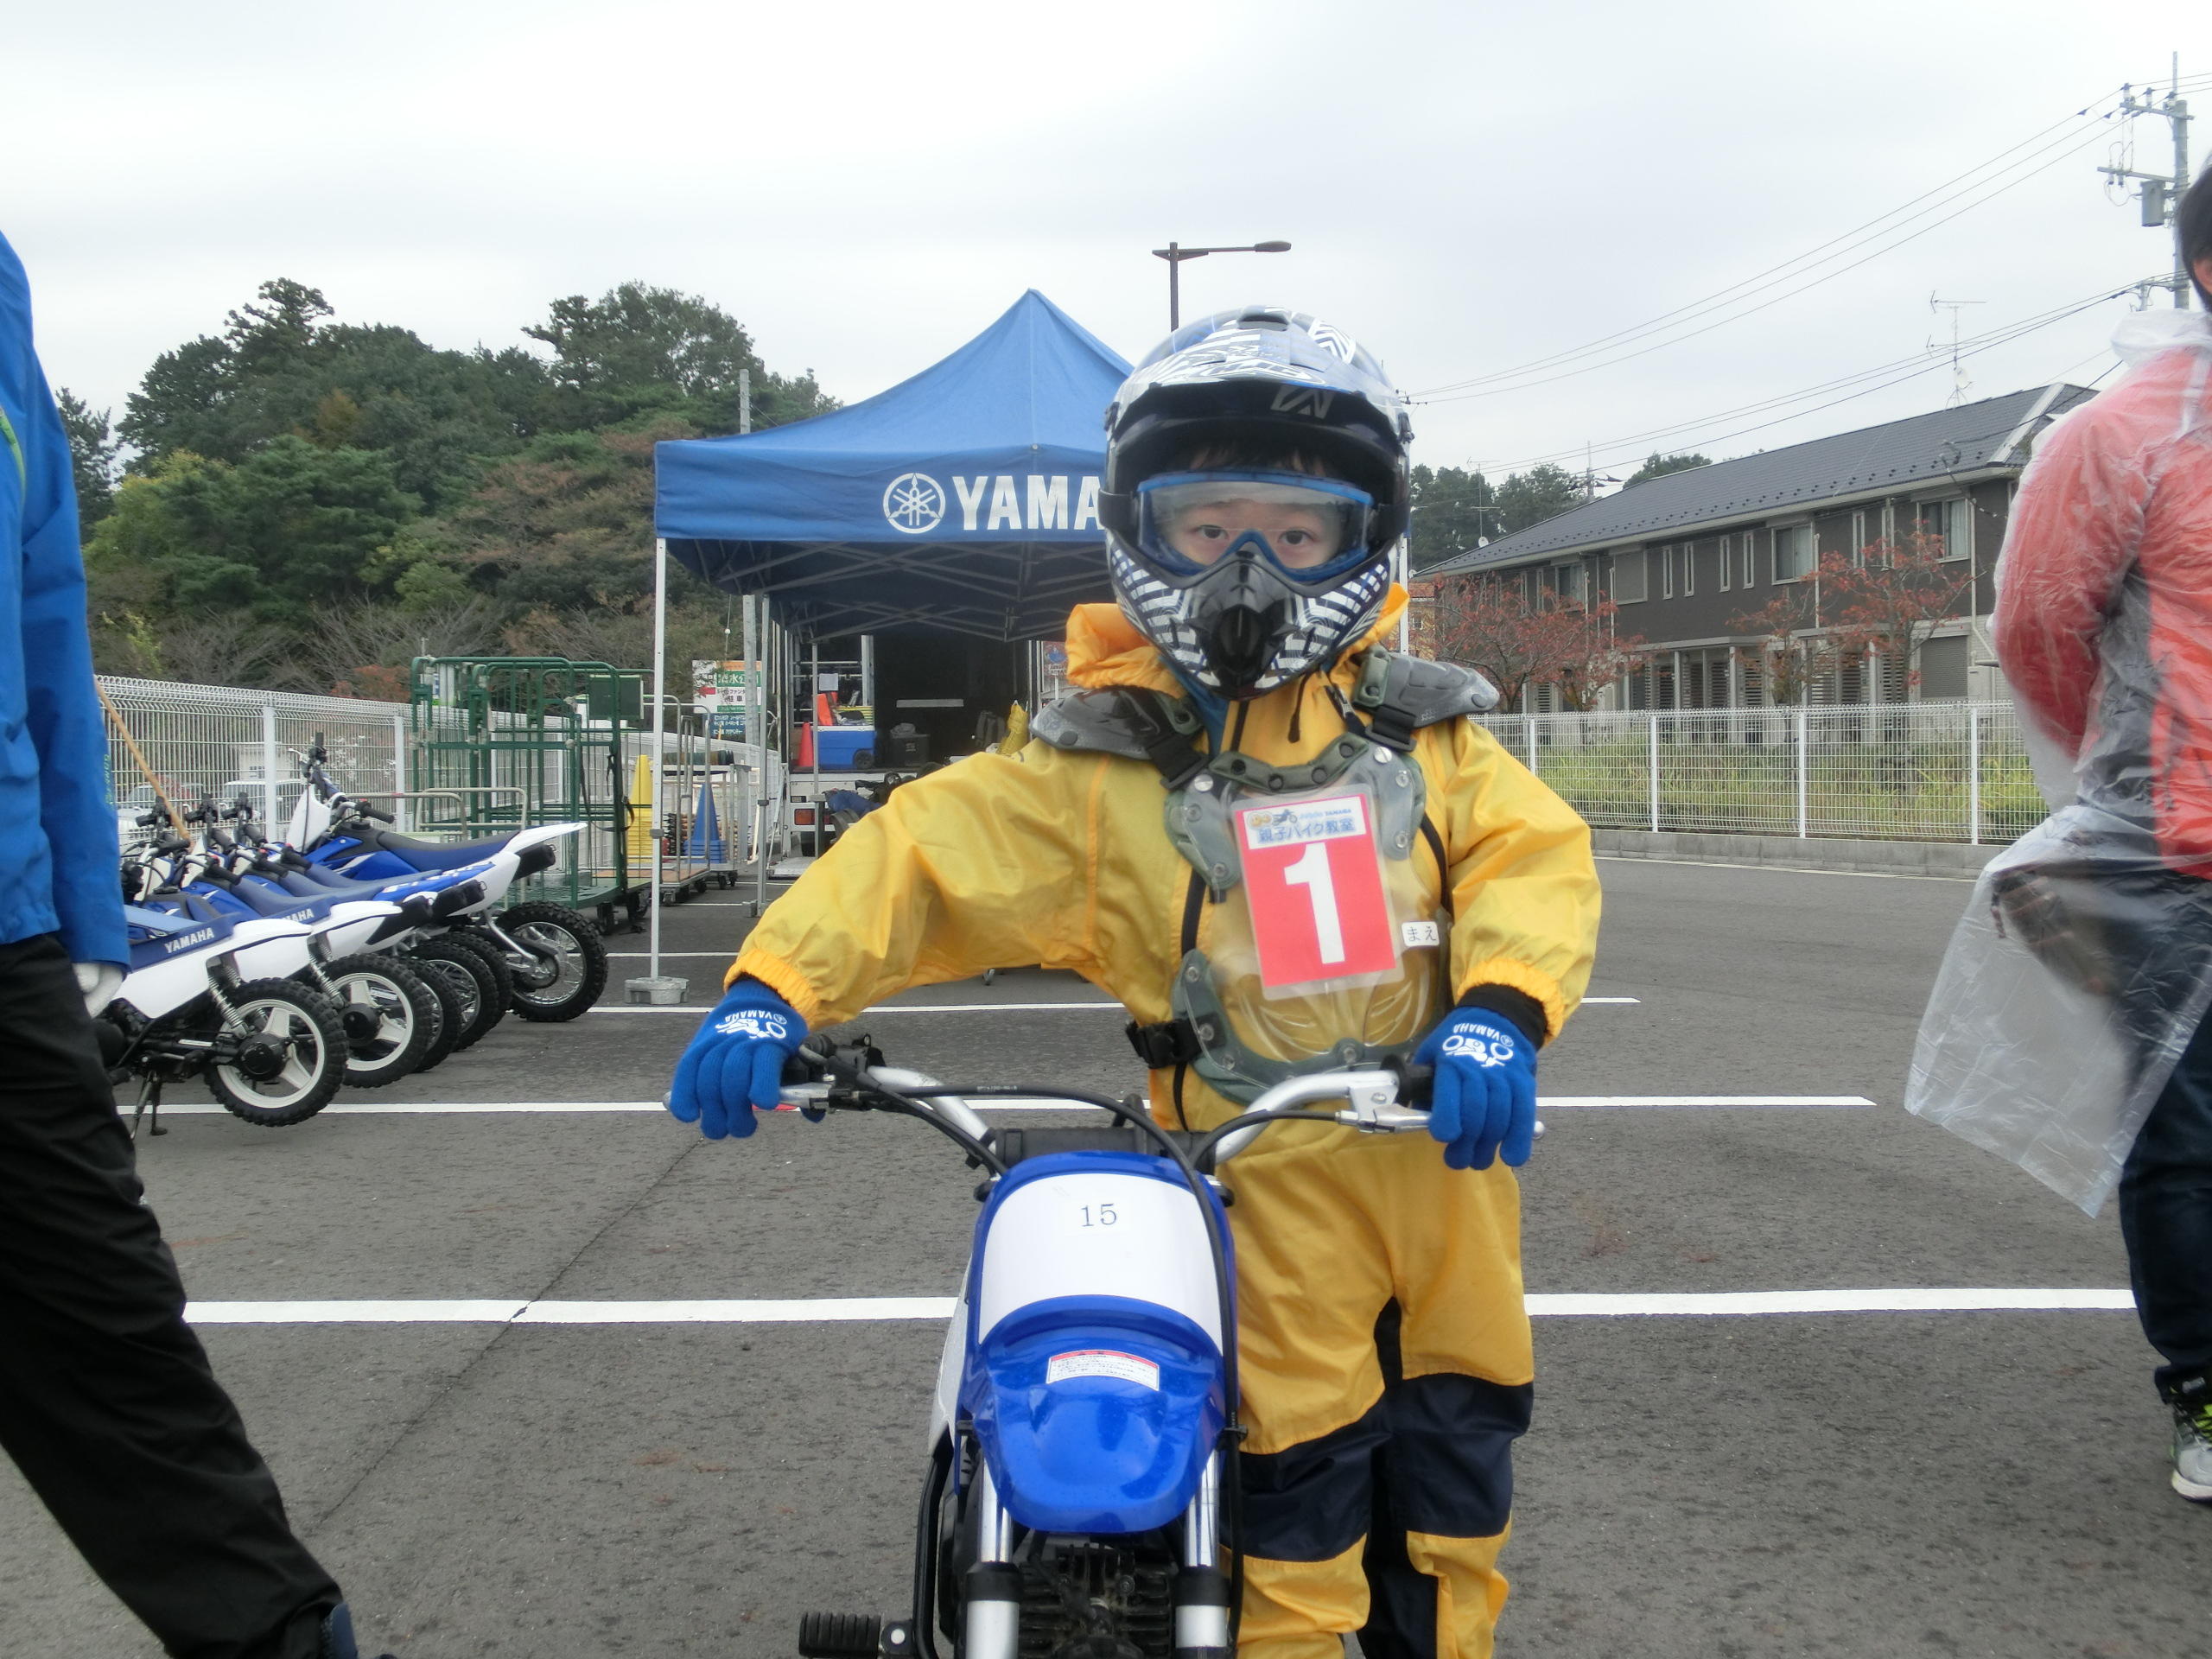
[285,747,608,1021]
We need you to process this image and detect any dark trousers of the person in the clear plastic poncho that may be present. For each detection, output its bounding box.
[2119,1020,2212,1398]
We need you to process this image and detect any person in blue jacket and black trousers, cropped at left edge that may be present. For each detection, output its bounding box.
[0,238,389,1659]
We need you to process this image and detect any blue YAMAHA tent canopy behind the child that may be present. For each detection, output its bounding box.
[652,289,1128,639]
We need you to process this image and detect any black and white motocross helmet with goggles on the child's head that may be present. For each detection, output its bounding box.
[1099,305,1414,699]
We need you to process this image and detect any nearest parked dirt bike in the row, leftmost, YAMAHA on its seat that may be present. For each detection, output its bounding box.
[99,905,345,1135]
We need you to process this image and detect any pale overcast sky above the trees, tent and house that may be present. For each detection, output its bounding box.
[0,0,2212,486]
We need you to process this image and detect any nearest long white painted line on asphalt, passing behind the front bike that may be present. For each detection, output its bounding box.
[183,1285,2134,1325]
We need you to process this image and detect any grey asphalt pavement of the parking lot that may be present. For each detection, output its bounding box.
[0,861,2212,1659]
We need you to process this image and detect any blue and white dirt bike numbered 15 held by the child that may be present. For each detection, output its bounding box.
[783,1038,1429,1659]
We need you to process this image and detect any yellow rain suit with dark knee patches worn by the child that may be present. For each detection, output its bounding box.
[730,588,1597,1659]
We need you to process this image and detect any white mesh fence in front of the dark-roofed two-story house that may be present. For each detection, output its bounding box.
[1482,703,2044,842]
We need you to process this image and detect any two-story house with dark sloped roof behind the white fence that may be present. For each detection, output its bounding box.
[1414,383,2093,710]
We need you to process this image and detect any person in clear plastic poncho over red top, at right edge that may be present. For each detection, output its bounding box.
[1907,173,2212,1502]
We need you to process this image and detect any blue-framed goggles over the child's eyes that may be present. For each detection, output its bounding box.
[1137,471,1376,584]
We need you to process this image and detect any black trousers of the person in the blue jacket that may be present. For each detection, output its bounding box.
[0,936,339,1659]
